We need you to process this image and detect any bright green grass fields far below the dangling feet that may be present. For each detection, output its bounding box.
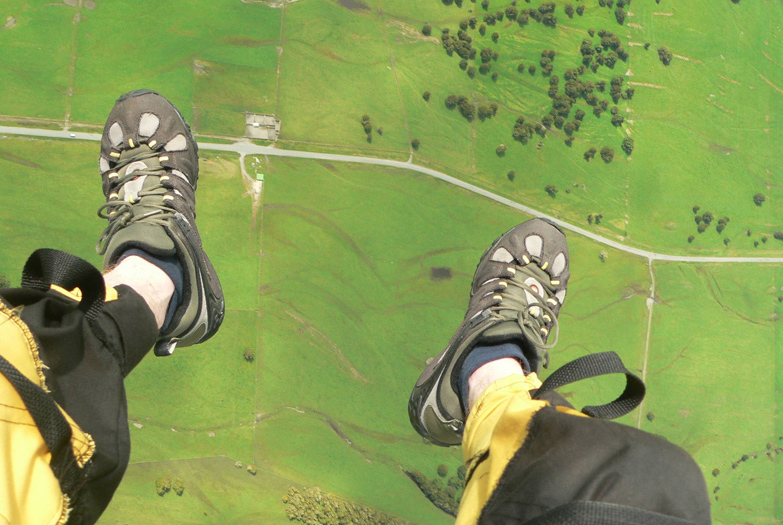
[0,0,783,525]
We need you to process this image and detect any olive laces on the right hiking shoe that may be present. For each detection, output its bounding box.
[490,266,560,350]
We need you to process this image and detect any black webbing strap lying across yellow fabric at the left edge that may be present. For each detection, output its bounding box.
[0,355,82,500]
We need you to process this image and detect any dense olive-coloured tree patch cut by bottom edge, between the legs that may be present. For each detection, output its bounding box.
[283,487,410,525]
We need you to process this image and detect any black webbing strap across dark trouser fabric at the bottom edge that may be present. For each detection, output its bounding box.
[520,501,695,525]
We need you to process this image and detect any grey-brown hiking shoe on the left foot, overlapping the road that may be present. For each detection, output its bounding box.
[97,89,225,355]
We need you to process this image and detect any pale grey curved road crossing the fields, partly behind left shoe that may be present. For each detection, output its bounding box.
[0,126,783,263]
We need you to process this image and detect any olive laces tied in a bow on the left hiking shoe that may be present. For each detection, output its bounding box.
[96,151,176,255]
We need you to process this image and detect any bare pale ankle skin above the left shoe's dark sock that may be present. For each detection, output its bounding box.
[103,255,174,328]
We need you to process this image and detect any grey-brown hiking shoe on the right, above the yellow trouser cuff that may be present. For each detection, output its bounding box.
[408,219,570,446]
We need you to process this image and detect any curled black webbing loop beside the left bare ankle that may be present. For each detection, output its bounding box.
[22,248,106,325]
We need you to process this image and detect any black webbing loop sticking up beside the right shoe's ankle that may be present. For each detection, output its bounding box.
[533,352,645,419]
